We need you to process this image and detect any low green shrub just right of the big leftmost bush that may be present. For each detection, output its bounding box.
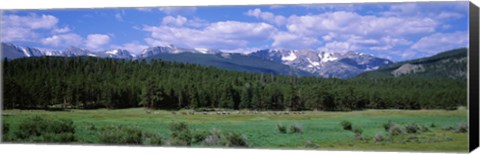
[98,125,143,144]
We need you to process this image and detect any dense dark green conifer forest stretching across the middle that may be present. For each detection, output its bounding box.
[2,57,467,111]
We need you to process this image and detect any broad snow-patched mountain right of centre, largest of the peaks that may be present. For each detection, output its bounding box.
[250,49,393,78]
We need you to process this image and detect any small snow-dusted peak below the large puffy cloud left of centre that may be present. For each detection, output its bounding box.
[139,44,221,58]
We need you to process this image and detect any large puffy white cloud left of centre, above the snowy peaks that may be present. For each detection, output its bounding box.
[143,21,277,49]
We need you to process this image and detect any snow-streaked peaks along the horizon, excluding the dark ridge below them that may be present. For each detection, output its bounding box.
[2,43,393,78]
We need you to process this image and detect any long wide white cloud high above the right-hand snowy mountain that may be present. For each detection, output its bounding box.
[287,11,437,36]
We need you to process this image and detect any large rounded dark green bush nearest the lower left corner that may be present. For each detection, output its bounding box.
[14,116,76,143]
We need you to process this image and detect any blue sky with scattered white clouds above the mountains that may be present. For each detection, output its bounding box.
[0,2,468,61]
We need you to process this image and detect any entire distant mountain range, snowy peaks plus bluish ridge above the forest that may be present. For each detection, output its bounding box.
[1,43,466,78]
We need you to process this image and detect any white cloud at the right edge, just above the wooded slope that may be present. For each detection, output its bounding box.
[411,31,468,54]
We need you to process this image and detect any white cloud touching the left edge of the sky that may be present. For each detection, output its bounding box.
[0,14,58,41]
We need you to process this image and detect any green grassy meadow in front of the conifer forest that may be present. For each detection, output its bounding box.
[2,108,468,152]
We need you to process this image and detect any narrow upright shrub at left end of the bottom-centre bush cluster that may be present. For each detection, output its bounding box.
[170,122,192,146]
